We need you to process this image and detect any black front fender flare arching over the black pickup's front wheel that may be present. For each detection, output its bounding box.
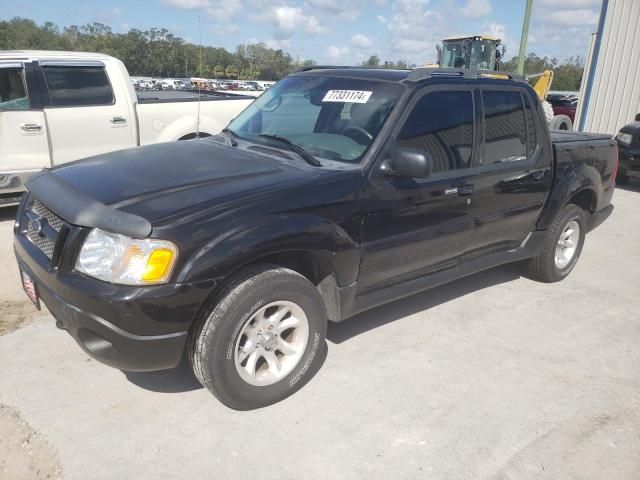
[178,213,360,286]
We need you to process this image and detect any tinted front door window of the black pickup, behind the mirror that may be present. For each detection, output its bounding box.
[398,91,473,173]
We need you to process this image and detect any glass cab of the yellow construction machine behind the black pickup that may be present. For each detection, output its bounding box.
[438,35,504,70]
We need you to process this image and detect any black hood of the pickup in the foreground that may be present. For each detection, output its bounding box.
[52,140,314,221]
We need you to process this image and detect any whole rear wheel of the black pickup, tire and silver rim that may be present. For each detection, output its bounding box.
[528,204,587,283]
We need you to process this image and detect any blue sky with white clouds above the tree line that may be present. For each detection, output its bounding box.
[0,0,601,64]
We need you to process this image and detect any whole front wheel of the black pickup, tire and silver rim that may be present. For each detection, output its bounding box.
[189,266,327,410]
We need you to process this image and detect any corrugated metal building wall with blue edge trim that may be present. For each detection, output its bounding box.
[576,0,640,135]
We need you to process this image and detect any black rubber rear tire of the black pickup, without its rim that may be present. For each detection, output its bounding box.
[527,204,587,283]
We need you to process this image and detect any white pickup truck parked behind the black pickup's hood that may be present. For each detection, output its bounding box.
[0,51,253,205]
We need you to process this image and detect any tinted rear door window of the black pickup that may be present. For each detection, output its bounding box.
[482,91,527,165]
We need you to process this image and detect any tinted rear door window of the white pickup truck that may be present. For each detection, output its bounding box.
[43,66,113,107]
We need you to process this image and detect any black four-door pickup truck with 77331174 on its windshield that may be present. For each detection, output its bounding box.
[15,68,617,409]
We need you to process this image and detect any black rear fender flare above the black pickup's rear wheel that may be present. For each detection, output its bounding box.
[537,165,602,230]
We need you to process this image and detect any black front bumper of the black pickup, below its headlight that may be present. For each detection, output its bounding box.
[14,235,213,371]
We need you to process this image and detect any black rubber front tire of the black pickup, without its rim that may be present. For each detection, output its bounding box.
[189,265,327,410]
